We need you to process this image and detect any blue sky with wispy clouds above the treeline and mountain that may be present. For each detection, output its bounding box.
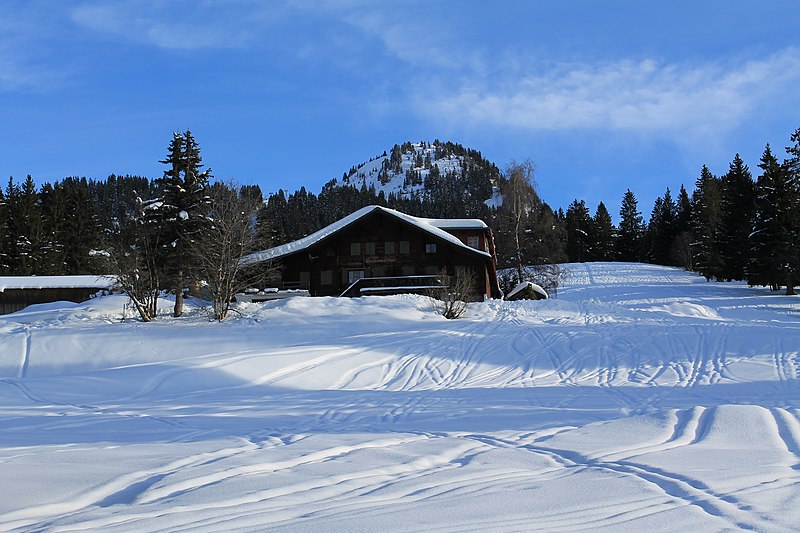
[0,0,800,215]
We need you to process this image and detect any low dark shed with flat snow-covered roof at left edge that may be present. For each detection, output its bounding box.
[0,276,116,315]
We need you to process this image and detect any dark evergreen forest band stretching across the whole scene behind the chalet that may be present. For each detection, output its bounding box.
[0,129,800,294]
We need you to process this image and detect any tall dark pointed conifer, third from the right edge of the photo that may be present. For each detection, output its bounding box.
[715,154,755,280]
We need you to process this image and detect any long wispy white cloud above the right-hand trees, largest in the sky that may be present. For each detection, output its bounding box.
[416,49,800,136]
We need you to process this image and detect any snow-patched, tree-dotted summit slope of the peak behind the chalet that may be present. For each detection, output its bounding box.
[341,140,502,207]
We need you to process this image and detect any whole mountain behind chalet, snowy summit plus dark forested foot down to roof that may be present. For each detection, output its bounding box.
[261,140,510,243]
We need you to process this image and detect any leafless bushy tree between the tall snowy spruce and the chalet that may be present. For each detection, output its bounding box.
[187,183,272,320]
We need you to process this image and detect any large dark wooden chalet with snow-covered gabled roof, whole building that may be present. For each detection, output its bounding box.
[244,205,501,299]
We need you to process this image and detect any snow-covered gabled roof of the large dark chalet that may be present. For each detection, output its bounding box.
[242,205,491,264]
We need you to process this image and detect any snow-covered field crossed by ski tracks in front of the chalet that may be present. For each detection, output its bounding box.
[0,263,800,531]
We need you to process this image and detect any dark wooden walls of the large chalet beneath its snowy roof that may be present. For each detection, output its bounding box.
[256,208,500,297]
